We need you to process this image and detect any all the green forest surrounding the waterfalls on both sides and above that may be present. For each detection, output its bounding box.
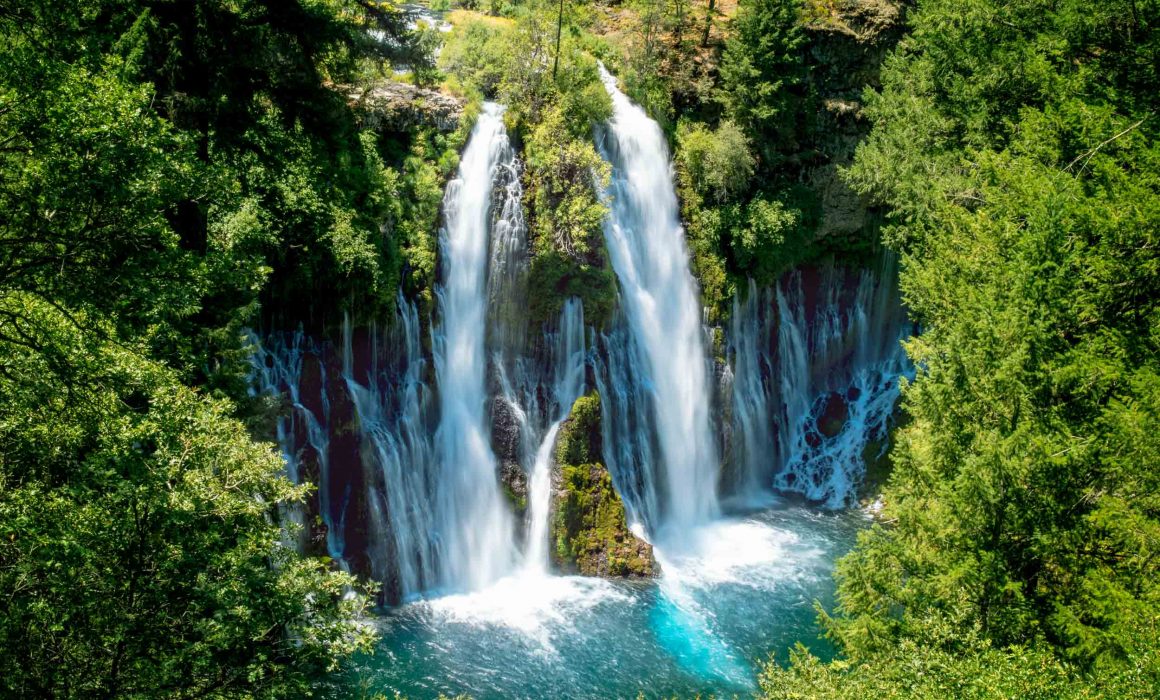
[0,0,1160,699]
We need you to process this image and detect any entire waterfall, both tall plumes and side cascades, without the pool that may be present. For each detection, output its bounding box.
[251,84,913,617]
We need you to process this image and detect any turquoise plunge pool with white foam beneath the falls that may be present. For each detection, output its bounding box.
[325,506,867,700]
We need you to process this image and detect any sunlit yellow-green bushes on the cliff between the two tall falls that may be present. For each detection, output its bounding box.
[440,2,616,327]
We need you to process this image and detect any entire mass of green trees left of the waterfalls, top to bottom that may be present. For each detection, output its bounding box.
[0,0,416,698]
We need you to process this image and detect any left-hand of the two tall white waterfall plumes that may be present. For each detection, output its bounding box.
[433,103,515,590]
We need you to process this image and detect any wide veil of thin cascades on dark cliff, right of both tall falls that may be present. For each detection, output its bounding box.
[728,259,914,508]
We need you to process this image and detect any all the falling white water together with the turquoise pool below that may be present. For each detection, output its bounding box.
[254,57,913,698]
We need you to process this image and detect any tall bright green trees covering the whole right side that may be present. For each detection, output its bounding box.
[770,0,1160,698]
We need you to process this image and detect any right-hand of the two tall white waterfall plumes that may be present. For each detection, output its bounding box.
[597,66,718,532]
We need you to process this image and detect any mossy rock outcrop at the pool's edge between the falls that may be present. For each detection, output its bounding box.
[551,394,657,577]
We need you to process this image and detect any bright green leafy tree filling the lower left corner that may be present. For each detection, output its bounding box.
[0,291,370,698]
